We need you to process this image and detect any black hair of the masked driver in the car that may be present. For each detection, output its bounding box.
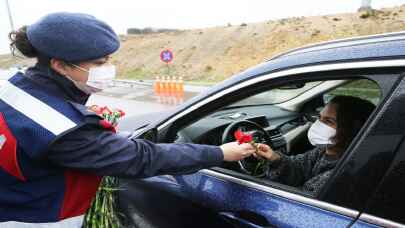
[328,96,375,155]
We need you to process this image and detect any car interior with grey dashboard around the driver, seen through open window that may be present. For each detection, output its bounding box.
[175,79,381,197]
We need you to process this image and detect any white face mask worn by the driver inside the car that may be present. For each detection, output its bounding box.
[308,120,336,146]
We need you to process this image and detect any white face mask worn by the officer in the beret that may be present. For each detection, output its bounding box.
[70,64,116,94]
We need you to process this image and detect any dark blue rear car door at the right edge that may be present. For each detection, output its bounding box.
[353,76,405,228]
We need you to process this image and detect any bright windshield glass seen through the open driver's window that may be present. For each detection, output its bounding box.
[228,81,322,107]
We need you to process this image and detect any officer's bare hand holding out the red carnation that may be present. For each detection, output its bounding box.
[220,142,256,161]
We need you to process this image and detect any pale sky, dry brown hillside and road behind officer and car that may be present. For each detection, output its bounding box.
[0,0,405,112]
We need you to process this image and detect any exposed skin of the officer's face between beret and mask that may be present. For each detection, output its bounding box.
[51,56,110,82]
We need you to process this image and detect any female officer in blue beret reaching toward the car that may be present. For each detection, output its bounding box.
[0,12,254,227]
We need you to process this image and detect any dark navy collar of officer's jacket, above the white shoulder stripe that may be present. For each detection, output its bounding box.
[25,64,90,105]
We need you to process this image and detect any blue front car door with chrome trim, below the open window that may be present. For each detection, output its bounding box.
[120,65,399,227]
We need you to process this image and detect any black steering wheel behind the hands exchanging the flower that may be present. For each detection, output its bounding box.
[222,120,272,177]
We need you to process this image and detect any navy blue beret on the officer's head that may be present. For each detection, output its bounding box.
[27,12,120,62]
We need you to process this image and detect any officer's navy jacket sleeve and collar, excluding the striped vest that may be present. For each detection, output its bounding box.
[30,65,223,178]
